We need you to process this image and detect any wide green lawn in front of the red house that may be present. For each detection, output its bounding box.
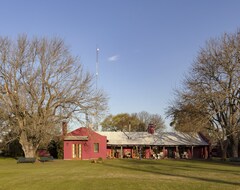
[0,159,240,190]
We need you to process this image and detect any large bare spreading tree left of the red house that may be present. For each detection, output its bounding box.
[0,35,107,157]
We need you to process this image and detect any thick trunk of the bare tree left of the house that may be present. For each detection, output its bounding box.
[19,131,38,158]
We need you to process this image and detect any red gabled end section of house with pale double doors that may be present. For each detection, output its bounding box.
[64,127,107,160]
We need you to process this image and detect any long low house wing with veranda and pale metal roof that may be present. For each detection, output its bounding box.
[99,132,209,159]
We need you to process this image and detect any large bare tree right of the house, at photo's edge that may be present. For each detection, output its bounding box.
[167,31,240,159]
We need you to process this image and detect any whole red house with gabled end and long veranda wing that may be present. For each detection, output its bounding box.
[64,127,209,160]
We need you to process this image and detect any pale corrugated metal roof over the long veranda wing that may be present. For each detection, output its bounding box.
[98,132,208,146]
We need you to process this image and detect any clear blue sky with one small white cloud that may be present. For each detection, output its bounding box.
[0,0,240,130]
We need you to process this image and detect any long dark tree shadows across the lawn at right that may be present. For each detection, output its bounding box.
[104,159,240,185]
